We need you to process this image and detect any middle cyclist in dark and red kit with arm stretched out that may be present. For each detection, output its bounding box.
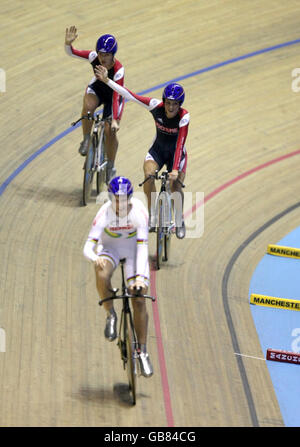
[95,66,190,239]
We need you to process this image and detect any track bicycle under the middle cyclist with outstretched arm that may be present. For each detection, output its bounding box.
[139,170,185,270]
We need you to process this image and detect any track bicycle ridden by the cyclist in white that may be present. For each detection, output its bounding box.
[99,259,155,405]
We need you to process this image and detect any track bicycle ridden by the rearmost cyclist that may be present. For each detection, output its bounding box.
[71,112,110,206]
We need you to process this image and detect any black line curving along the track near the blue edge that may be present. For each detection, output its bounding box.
[222,202,300,427]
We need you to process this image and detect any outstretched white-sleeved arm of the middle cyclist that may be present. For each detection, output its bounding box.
[95,65,161,110]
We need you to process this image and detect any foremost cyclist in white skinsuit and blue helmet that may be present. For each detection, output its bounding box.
[83,177,153,377]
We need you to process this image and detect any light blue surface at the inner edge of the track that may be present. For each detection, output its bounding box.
[249,227,300,427]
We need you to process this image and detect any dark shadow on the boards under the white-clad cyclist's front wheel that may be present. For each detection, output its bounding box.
[79,383,149,407]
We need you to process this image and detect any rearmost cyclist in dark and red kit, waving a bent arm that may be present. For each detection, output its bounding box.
[65,26,124,176]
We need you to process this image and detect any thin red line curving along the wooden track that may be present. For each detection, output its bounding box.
[150,149,300,427]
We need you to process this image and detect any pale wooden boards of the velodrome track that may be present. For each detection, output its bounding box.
[0,0,300,427]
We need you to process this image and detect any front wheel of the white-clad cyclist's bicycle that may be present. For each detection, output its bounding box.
[124,313,136,405]
